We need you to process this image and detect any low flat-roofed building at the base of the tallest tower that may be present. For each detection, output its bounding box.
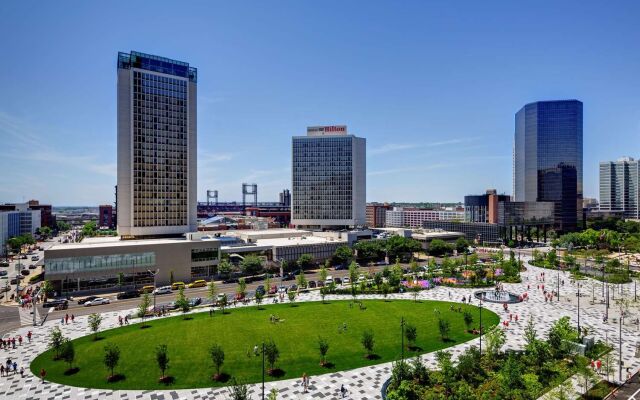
[44,233,220,294]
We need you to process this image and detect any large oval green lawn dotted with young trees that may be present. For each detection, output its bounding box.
[31,300,498,389]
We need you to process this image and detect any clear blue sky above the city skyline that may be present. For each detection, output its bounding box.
[0,1,640,205]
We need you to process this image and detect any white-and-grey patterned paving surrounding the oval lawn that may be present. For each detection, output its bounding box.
[0,258,640,400]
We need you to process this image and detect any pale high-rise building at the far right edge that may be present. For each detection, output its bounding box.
[600,157,640,219]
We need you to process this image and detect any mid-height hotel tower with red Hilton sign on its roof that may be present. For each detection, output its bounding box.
[291,125,366,229]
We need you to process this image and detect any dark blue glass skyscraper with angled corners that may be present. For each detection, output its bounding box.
[513,100,583,232]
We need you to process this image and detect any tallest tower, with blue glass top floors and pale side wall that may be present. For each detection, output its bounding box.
[117,51,197,239]
